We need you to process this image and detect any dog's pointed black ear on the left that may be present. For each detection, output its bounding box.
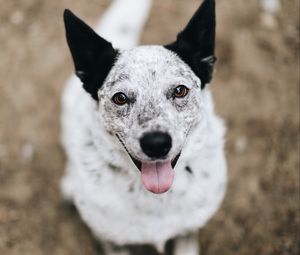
[64,10,118,100]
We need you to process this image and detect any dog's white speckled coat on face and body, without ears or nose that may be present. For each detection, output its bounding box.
[62,0,226,255]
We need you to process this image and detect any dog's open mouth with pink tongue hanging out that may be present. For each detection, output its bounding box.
[117,135,180,194]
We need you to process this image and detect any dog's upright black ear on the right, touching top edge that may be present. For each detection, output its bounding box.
[165,0,216,88]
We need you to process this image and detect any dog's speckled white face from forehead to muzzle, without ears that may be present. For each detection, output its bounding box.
[98,46,201,162]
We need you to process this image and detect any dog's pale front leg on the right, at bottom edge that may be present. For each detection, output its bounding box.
[174,232,200,255]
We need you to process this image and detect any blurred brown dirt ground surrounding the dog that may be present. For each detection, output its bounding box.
[0,0,300,255]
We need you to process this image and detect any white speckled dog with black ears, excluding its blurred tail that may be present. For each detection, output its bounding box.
[62,0,226,255]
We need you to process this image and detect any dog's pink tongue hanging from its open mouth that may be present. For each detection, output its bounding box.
[142,161,174,194]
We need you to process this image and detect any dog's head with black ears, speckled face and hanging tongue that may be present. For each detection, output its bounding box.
[64,0,215,193]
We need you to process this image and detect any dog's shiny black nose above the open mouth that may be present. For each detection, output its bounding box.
[140,132,172,158]
